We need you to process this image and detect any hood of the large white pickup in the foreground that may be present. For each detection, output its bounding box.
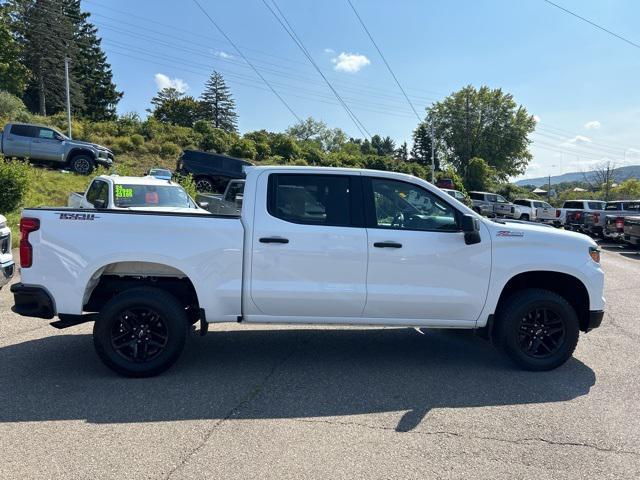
[483,219,598,248]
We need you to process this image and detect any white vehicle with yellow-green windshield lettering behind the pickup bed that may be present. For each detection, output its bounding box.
[67,175,208,214]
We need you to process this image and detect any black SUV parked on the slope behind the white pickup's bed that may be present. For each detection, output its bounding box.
[176,150,253,193]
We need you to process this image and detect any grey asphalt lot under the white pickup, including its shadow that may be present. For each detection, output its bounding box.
[0,248,640,479]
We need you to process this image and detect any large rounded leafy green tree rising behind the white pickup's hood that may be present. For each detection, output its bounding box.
[427,85,535,181]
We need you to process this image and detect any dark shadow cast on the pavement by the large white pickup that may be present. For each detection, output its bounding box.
[0,328,595,431]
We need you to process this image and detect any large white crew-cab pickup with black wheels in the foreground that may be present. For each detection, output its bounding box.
[11,167,605,376]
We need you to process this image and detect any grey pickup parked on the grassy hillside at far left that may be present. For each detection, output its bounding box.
[0,123,114,175]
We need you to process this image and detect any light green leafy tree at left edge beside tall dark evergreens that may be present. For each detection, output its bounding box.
[0,5,29,97]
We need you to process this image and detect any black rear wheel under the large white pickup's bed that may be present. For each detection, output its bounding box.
[93,287,189,377]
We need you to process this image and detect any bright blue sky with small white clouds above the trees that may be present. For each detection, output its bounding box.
[83,0,640,177]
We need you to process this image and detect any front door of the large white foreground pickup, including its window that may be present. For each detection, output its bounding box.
[363,177,491,323]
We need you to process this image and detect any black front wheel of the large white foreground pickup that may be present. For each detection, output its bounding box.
[495,288,579,371]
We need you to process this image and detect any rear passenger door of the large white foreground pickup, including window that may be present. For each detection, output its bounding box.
[248,172,367,322]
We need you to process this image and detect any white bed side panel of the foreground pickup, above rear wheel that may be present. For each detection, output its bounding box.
[22,208,244,321]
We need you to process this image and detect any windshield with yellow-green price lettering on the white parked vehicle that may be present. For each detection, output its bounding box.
[113,184,196,208]
